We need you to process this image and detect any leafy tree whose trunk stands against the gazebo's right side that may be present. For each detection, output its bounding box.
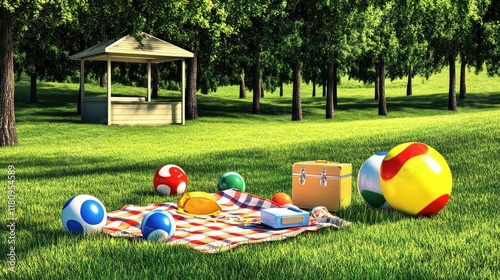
[172,0,235,119]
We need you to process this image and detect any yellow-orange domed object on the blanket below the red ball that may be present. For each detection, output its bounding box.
[177,192,222,215]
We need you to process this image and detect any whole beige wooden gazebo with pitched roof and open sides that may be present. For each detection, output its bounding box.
[71,32,193,125]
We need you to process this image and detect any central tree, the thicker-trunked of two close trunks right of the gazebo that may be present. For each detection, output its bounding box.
[228,0,290,114]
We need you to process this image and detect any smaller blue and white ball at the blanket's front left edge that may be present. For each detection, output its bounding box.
[141,210,176,242]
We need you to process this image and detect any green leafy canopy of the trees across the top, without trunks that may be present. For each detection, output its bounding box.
[7,0,499,91]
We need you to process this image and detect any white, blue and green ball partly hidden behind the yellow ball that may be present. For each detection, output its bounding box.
[357,152,391,209]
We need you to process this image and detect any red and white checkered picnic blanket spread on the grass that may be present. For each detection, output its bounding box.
[104,189,350,254]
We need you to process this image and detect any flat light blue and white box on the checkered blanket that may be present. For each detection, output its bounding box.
[260,207,309,229]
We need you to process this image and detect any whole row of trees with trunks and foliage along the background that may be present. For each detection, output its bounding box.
[0,0,500,146]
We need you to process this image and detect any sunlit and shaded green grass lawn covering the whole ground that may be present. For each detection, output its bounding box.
[0,68,500,279]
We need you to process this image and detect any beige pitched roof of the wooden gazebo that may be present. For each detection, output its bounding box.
[71,32,194,63]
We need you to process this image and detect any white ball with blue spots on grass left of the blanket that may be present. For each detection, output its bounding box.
[61,194,107,234]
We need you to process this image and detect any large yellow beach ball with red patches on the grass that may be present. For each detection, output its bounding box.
[380,142,452,216]
